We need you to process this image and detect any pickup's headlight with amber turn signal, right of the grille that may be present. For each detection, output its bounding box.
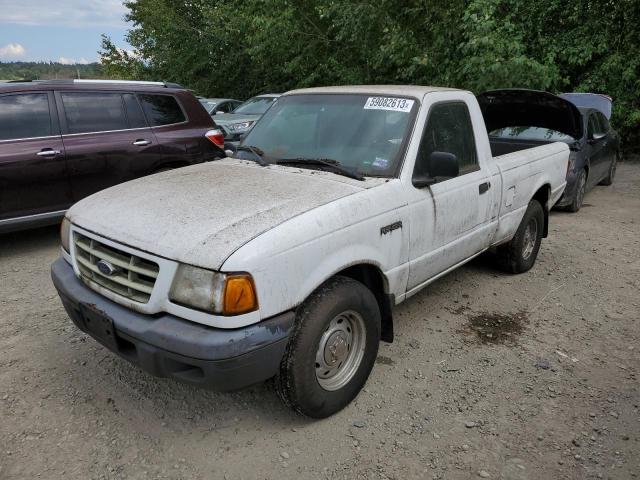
[169,265,258,315]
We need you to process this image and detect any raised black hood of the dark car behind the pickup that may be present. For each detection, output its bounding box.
[478,89,582,140]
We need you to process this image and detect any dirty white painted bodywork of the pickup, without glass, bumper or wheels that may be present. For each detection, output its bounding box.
[69,86,569,328]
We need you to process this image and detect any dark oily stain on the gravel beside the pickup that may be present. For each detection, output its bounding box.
[467,311,527,344]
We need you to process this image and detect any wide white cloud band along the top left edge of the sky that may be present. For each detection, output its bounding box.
[0,0,127,28]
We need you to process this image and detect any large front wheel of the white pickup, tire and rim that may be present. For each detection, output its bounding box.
[275,276,381,418]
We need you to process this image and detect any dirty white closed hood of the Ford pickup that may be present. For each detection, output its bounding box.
[67,159,384,269]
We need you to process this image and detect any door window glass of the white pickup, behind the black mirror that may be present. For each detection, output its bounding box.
[414,102,480,175]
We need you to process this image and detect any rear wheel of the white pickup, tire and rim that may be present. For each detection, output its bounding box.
[497,200,544,273]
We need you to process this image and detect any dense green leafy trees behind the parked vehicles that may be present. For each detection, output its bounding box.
[101,0,640,147]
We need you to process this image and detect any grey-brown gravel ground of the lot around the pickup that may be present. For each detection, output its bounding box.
[0,163,640,479]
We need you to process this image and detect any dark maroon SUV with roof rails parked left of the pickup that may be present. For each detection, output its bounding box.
[0,80,224,232]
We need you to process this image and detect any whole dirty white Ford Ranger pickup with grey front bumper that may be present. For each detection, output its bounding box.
[52,86,569,418]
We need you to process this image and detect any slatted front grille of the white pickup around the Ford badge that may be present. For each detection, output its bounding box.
[74,232,160,303]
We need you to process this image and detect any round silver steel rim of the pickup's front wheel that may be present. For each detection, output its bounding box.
[315,310,366,391]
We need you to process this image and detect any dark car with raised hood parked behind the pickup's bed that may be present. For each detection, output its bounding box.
[478,89,620,212]
